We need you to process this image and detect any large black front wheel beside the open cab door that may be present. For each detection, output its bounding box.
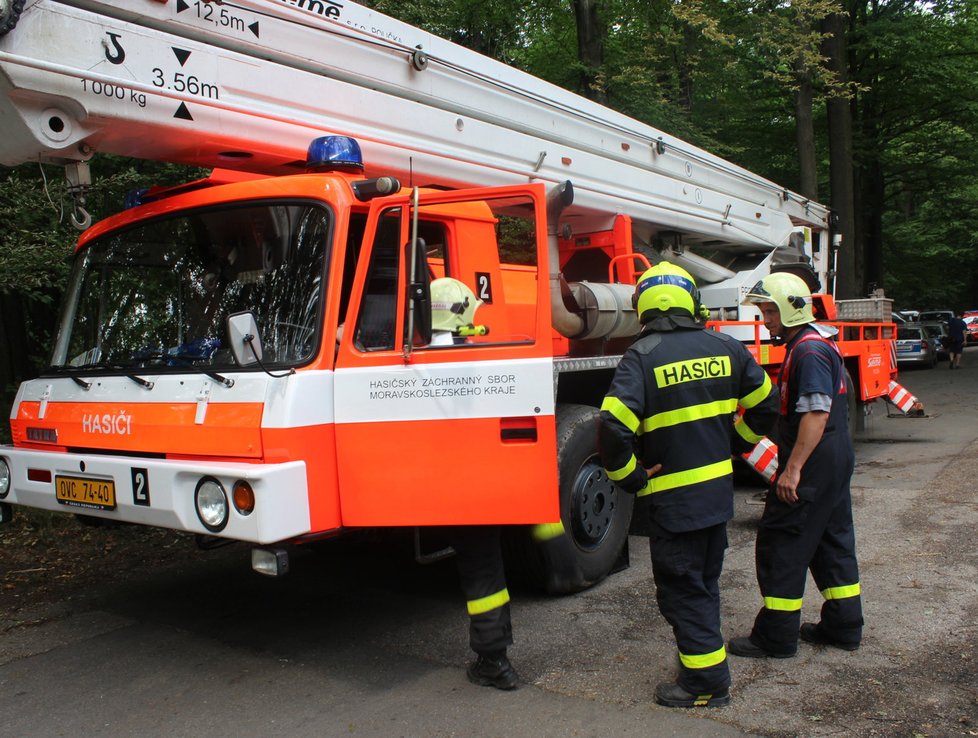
[505,405,635,594]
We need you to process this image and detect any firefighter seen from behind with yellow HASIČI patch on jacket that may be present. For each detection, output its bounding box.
[599,262,777,707]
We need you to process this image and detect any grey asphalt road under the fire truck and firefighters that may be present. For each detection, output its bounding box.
[0,348,978,738]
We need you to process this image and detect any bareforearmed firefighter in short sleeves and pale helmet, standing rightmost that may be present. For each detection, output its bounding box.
[729,273,863,658]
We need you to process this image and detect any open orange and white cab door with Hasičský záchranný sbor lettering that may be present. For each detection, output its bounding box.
[335,185,560,526]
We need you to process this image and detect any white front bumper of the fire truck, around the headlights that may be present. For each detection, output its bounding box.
[0,446,310,543]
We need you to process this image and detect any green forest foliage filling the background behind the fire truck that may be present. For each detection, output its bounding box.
[0,0,978,380]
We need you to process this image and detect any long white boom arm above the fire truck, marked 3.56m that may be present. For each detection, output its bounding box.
[0,0,828,281]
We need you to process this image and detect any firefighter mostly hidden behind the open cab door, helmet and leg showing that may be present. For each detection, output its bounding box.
[431,277,519,689]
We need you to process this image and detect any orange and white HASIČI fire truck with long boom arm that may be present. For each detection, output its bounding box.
[0,0,916,591]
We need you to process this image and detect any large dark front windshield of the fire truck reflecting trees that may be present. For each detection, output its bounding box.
[52,202,333,371]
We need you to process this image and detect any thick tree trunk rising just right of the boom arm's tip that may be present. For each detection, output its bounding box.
[822,13,862,299]
